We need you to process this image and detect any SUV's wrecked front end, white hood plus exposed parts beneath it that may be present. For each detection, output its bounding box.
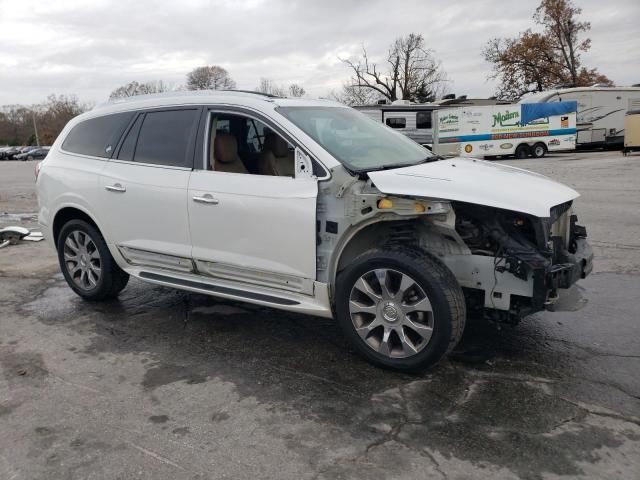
[342,159,593,323]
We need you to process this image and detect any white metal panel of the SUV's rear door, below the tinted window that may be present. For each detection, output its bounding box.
[93,160,191,257]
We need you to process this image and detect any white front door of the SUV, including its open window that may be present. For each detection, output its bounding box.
[188,111,318,293]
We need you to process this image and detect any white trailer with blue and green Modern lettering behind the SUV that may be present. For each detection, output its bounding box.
[433,101,577,158]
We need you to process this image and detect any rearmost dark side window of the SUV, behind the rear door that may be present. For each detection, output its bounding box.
[62,112,134,158]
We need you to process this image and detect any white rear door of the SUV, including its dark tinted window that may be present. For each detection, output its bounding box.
[99,108,200,270]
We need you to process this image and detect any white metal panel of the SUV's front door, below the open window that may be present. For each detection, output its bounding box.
[188,171,318,279]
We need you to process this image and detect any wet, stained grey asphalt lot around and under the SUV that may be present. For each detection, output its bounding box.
[0,152,640,480]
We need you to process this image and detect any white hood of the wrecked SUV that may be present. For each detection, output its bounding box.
[369,157,580,217]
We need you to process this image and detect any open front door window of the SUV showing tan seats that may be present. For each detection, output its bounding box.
[207,112,295,177]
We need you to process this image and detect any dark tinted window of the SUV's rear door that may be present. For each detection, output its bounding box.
[132,109,199,167]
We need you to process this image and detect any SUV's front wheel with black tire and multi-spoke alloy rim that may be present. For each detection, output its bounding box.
[335,246,466,371]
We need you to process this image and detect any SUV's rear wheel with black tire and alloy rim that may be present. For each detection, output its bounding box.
[56,220,129,300]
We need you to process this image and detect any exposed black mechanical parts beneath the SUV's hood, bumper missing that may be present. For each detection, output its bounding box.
[453,201,593,323]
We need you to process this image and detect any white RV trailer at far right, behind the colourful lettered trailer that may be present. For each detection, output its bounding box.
[520,87,640,147]
